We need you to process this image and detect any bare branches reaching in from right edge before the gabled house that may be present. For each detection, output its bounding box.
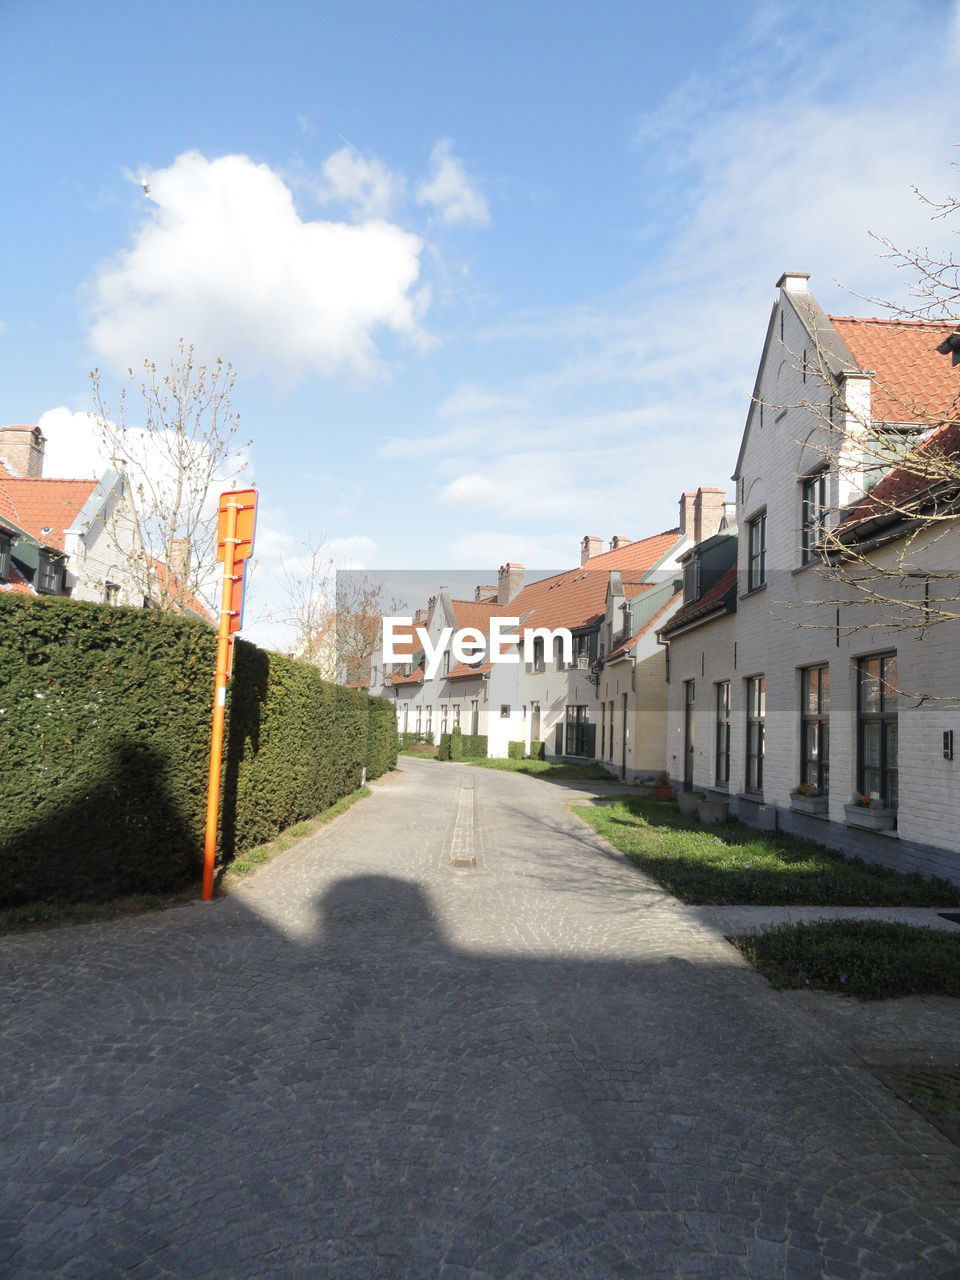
[763,177,960,630]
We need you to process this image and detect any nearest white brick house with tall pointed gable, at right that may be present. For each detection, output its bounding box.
[662,274,960,881]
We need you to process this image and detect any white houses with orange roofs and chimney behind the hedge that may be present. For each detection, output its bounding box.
[0,426,212,622]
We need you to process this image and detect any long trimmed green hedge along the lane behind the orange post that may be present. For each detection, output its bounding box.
[0,594,397,905]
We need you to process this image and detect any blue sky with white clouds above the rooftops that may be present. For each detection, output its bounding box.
[0,0,960,639]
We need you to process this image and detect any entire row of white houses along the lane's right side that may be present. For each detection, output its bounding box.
[371,273,960,881]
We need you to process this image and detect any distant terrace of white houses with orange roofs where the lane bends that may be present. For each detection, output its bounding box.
[371,499,723,780]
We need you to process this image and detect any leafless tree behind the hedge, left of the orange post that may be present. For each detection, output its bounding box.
[90,340,251,612]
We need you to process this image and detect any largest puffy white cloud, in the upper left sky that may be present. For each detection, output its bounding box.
[91,151,425,376]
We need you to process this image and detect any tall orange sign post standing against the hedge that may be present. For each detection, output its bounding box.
[202,489,257,901]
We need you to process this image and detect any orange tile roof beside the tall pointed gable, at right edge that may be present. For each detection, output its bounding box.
[829,316,960,424]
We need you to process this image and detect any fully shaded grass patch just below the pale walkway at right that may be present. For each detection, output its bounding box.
[730,920,960,1000]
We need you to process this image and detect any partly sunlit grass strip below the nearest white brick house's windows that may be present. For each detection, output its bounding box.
[573,797,960,906]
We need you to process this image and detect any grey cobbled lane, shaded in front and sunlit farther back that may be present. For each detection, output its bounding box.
[0,760,960,1280]
